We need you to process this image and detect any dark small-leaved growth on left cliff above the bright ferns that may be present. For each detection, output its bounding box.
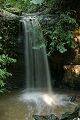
[0,17,19,58]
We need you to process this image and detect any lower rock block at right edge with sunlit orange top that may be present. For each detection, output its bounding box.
[63,65,80,89]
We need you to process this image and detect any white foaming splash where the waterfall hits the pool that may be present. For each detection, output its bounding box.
[20,92,69,107]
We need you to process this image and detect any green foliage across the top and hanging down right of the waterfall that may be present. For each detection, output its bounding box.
[1,0,79,53]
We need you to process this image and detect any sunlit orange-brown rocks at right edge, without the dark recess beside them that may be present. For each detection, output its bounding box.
[63,29,80,88]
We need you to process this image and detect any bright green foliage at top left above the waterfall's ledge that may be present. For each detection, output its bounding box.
[0,0,44,13]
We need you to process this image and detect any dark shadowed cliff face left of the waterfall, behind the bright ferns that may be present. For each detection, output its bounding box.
[0,10,24,87]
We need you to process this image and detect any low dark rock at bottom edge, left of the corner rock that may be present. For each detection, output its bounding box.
[33,114,59,120]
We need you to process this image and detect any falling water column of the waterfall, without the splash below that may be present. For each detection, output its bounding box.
[20,16,51,91]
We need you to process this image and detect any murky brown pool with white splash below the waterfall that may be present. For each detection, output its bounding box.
[0,90,80,120]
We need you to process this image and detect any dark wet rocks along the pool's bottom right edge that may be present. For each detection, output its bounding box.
[33,106,80,120]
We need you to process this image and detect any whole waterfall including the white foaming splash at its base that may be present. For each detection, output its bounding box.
[19,15,72,116]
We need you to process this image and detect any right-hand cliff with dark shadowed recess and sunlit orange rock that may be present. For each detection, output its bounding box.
[49,29,80,89]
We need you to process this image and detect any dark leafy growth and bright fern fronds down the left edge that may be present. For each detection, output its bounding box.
[0,12,19,92]
